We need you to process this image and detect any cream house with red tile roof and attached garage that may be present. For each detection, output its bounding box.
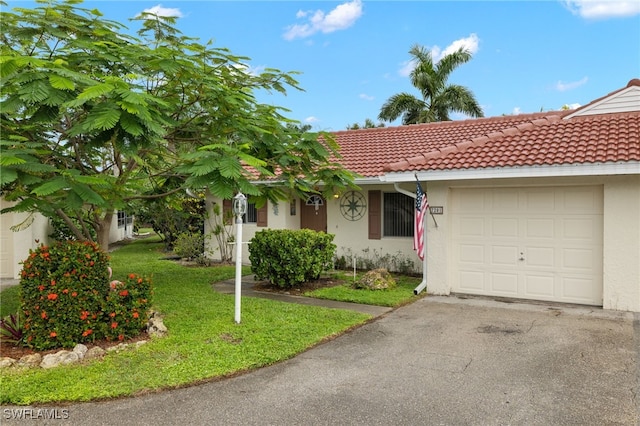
[205,79,640,312]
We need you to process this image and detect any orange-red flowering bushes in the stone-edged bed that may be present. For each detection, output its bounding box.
[20,241,151,350]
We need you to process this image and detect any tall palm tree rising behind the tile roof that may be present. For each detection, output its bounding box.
[378,45,484,124]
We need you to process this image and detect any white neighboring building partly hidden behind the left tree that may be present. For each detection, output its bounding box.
[0,203,133,279]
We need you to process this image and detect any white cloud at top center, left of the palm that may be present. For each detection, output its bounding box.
[283,0,362,40]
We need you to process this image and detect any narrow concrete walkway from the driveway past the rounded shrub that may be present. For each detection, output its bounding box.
[213,275,393,317]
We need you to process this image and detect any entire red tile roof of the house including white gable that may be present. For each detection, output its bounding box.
[334,79,640,177]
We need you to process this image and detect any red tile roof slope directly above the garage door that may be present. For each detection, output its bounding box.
[385,112,640,172]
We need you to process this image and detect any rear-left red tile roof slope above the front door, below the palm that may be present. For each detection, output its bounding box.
[332,111,566,177]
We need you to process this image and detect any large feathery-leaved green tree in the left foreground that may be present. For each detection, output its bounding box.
[0,0,353,248]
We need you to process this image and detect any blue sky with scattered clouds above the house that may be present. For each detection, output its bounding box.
[9,0,640,130]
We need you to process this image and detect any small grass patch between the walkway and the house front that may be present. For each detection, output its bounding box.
[304,274,425,308]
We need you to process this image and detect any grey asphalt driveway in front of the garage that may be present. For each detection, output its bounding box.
[0,297,640,425]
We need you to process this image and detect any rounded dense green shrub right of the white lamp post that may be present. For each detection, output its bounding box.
[249,229,336,288]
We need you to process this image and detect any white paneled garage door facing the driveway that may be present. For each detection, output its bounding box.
[451,186,603,305]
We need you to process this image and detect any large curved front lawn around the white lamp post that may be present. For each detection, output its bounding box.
[0,238,371,405]
